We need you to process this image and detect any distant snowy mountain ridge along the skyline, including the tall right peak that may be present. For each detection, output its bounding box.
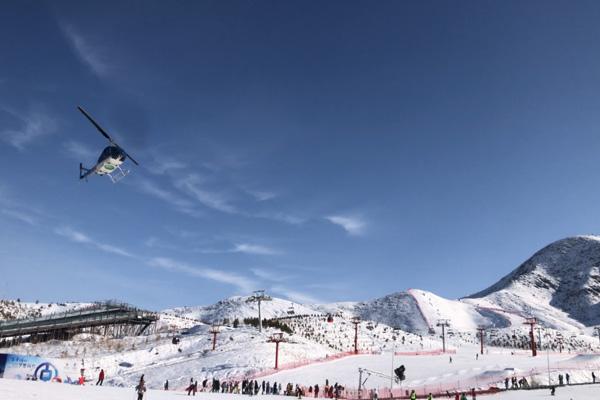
[163,236,600,334]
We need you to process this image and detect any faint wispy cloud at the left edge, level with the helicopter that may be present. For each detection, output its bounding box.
[0,108,58,150]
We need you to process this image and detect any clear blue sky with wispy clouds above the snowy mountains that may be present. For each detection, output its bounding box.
[0,1,600,309]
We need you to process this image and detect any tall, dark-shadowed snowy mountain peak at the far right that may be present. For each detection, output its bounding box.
[468,236,600,328]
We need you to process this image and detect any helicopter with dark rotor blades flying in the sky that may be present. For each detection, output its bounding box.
[77,106,139,183]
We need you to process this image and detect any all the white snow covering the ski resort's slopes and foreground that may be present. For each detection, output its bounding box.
[0,236,600,400]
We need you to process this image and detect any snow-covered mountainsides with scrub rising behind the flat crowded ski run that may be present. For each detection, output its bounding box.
[0,236,600,387]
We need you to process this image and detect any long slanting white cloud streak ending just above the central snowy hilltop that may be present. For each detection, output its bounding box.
[148,257,256,293]
